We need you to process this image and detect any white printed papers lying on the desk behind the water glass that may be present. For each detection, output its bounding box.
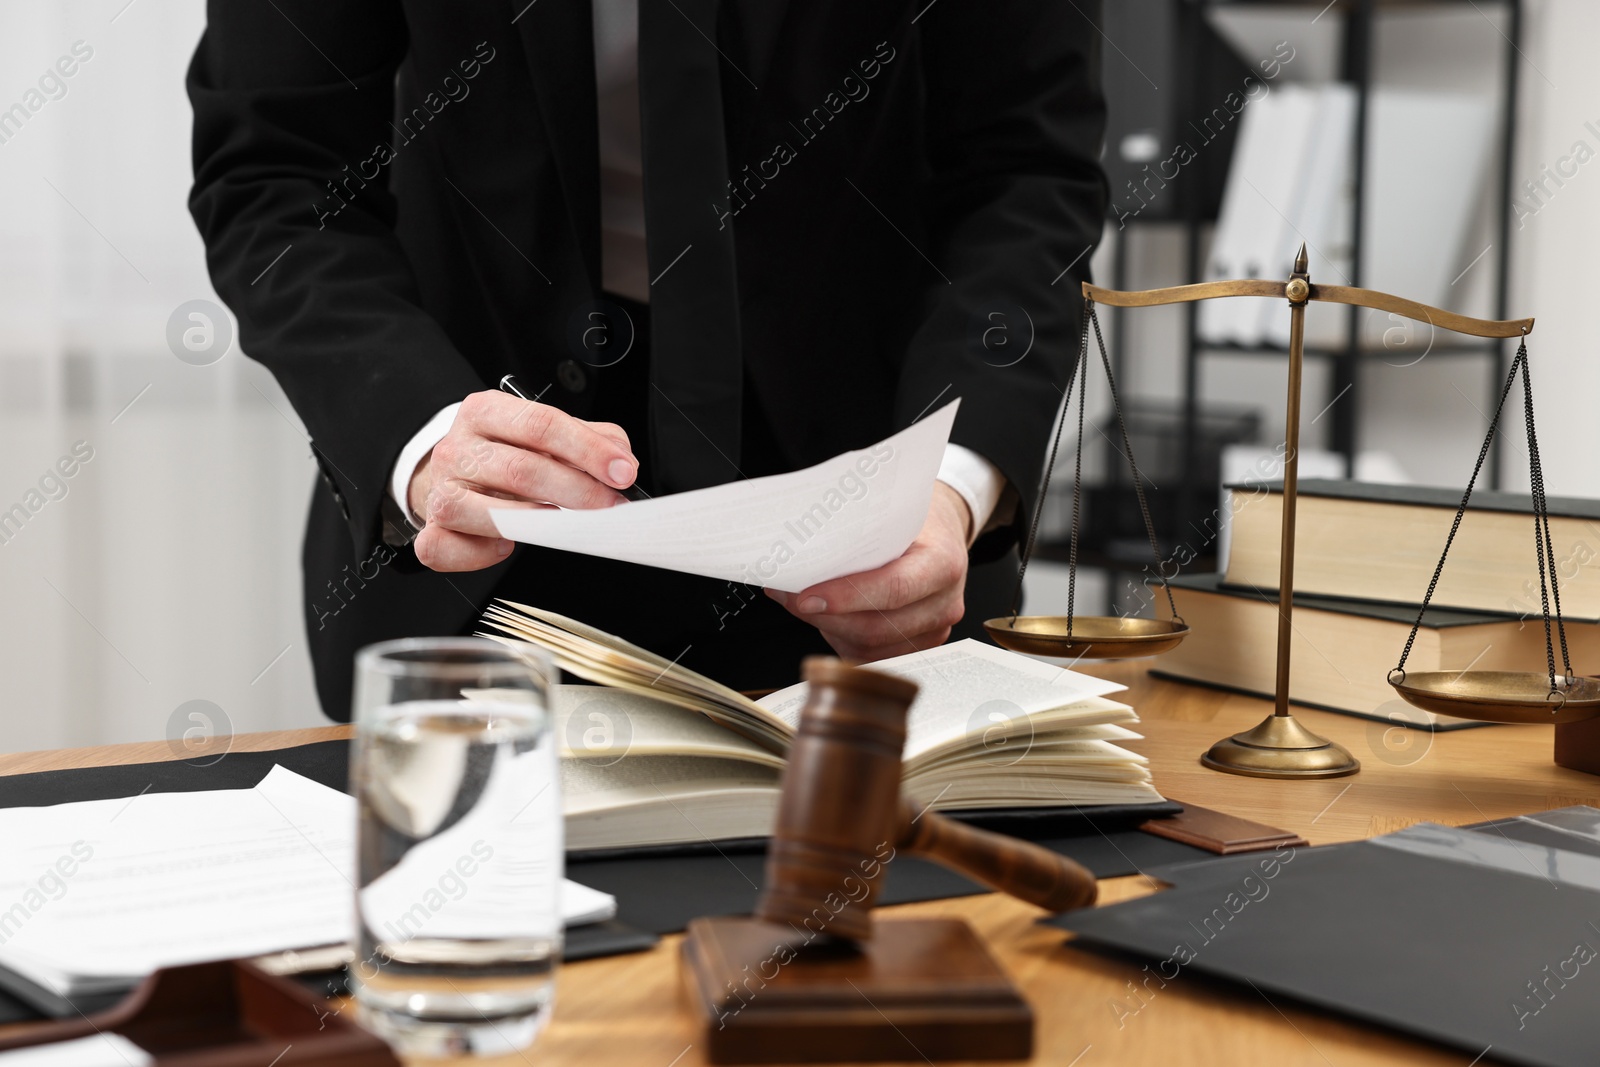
[0,766,614,993]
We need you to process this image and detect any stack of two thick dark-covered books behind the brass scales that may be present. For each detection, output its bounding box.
[1157,478,1600,728]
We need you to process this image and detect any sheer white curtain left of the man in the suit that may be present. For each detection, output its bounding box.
[0,0,323,752]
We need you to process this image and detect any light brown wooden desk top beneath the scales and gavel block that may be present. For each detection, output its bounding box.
[0,664,1600,1067]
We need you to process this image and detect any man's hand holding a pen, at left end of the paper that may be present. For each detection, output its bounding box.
[406,390,638,571]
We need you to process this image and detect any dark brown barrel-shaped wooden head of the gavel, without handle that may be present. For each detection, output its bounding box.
[755,656,917,941]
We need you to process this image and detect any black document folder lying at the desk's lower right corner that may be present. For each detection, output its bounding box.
[1050,809,1600,1067]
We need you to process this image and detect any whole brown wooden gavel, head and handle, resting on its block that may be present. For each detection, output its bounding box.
[755,656,1096,941]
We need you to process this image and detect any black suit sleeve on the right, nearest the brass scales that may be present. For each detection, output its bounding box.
[896,0,1107,558]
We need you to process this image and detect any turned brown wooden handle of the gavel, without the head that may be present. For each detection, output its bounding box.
[896,798,1099,912]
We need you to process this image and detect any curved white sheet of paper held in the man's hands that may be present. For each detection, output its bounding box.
[490,400,960,593]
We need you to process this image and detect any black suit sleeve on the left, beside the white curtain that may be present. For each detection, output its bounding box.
[187,0,483,558]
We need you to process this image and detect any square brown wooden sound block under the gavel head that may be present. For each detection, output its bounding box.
[682,917,1034,1064]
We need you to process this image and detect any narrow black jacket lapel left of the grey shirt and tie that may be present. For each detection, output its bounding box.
[509,0,600,290]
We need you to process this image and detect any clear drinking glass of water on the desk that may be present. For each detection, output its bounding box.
[350,638,562,1057]
